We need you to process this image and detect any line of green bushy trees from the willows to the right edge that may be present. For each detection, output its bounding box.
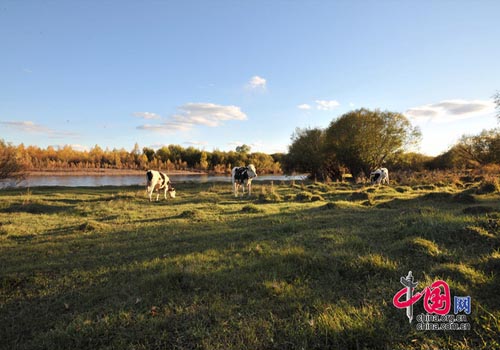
[282,108,500,180]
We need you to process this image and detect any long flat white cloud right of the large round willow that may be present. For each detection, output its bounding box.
[406,100,495,122]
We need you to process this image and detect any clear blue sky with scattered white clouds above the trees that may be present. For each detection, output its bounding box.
[0,0,500,155]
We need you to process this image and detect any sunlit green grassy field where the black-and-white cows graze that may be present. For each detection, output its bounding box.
[0,179,500,349]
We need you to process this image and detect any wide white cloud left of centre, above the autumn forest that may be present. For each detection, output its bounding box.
[137,103,247,133]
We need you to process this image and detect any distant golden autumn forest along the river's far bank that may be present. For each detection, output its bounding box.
[0,140,283,174]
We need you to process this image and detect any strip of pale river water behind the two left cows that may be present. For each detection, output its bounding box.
[0,175,305,188]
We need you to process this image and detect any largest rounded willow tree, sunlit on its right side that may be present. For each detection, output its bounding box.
[324,108,420,176]
